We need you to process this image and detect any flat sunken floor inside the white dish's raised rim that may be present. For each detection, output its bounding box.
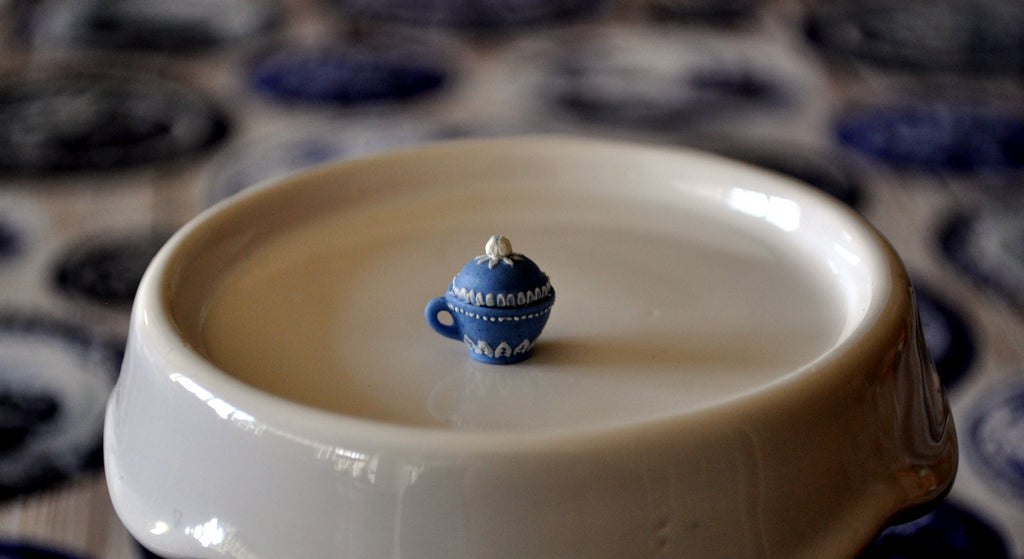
[201,187,847,430]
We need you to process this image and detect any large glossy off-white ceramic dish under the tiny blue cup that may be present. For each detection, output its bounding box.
[105,137,956,559]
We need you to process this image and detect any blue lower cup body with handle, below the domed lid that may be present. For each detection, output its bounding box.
[425,289,555,364]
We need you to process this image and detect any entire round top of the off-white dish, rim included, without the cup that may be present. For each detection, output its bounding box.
[161,137,893,431]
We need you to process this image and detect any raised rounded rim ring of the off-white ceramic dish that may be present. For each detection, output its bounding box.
[129,134,913,454]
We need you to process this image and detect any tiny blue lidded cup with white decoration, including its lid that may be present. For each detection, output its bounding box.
[424,234,555,364]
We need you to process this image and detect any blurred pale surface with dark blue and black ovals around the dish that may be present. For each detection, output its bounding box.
[0,0,1024,559]
